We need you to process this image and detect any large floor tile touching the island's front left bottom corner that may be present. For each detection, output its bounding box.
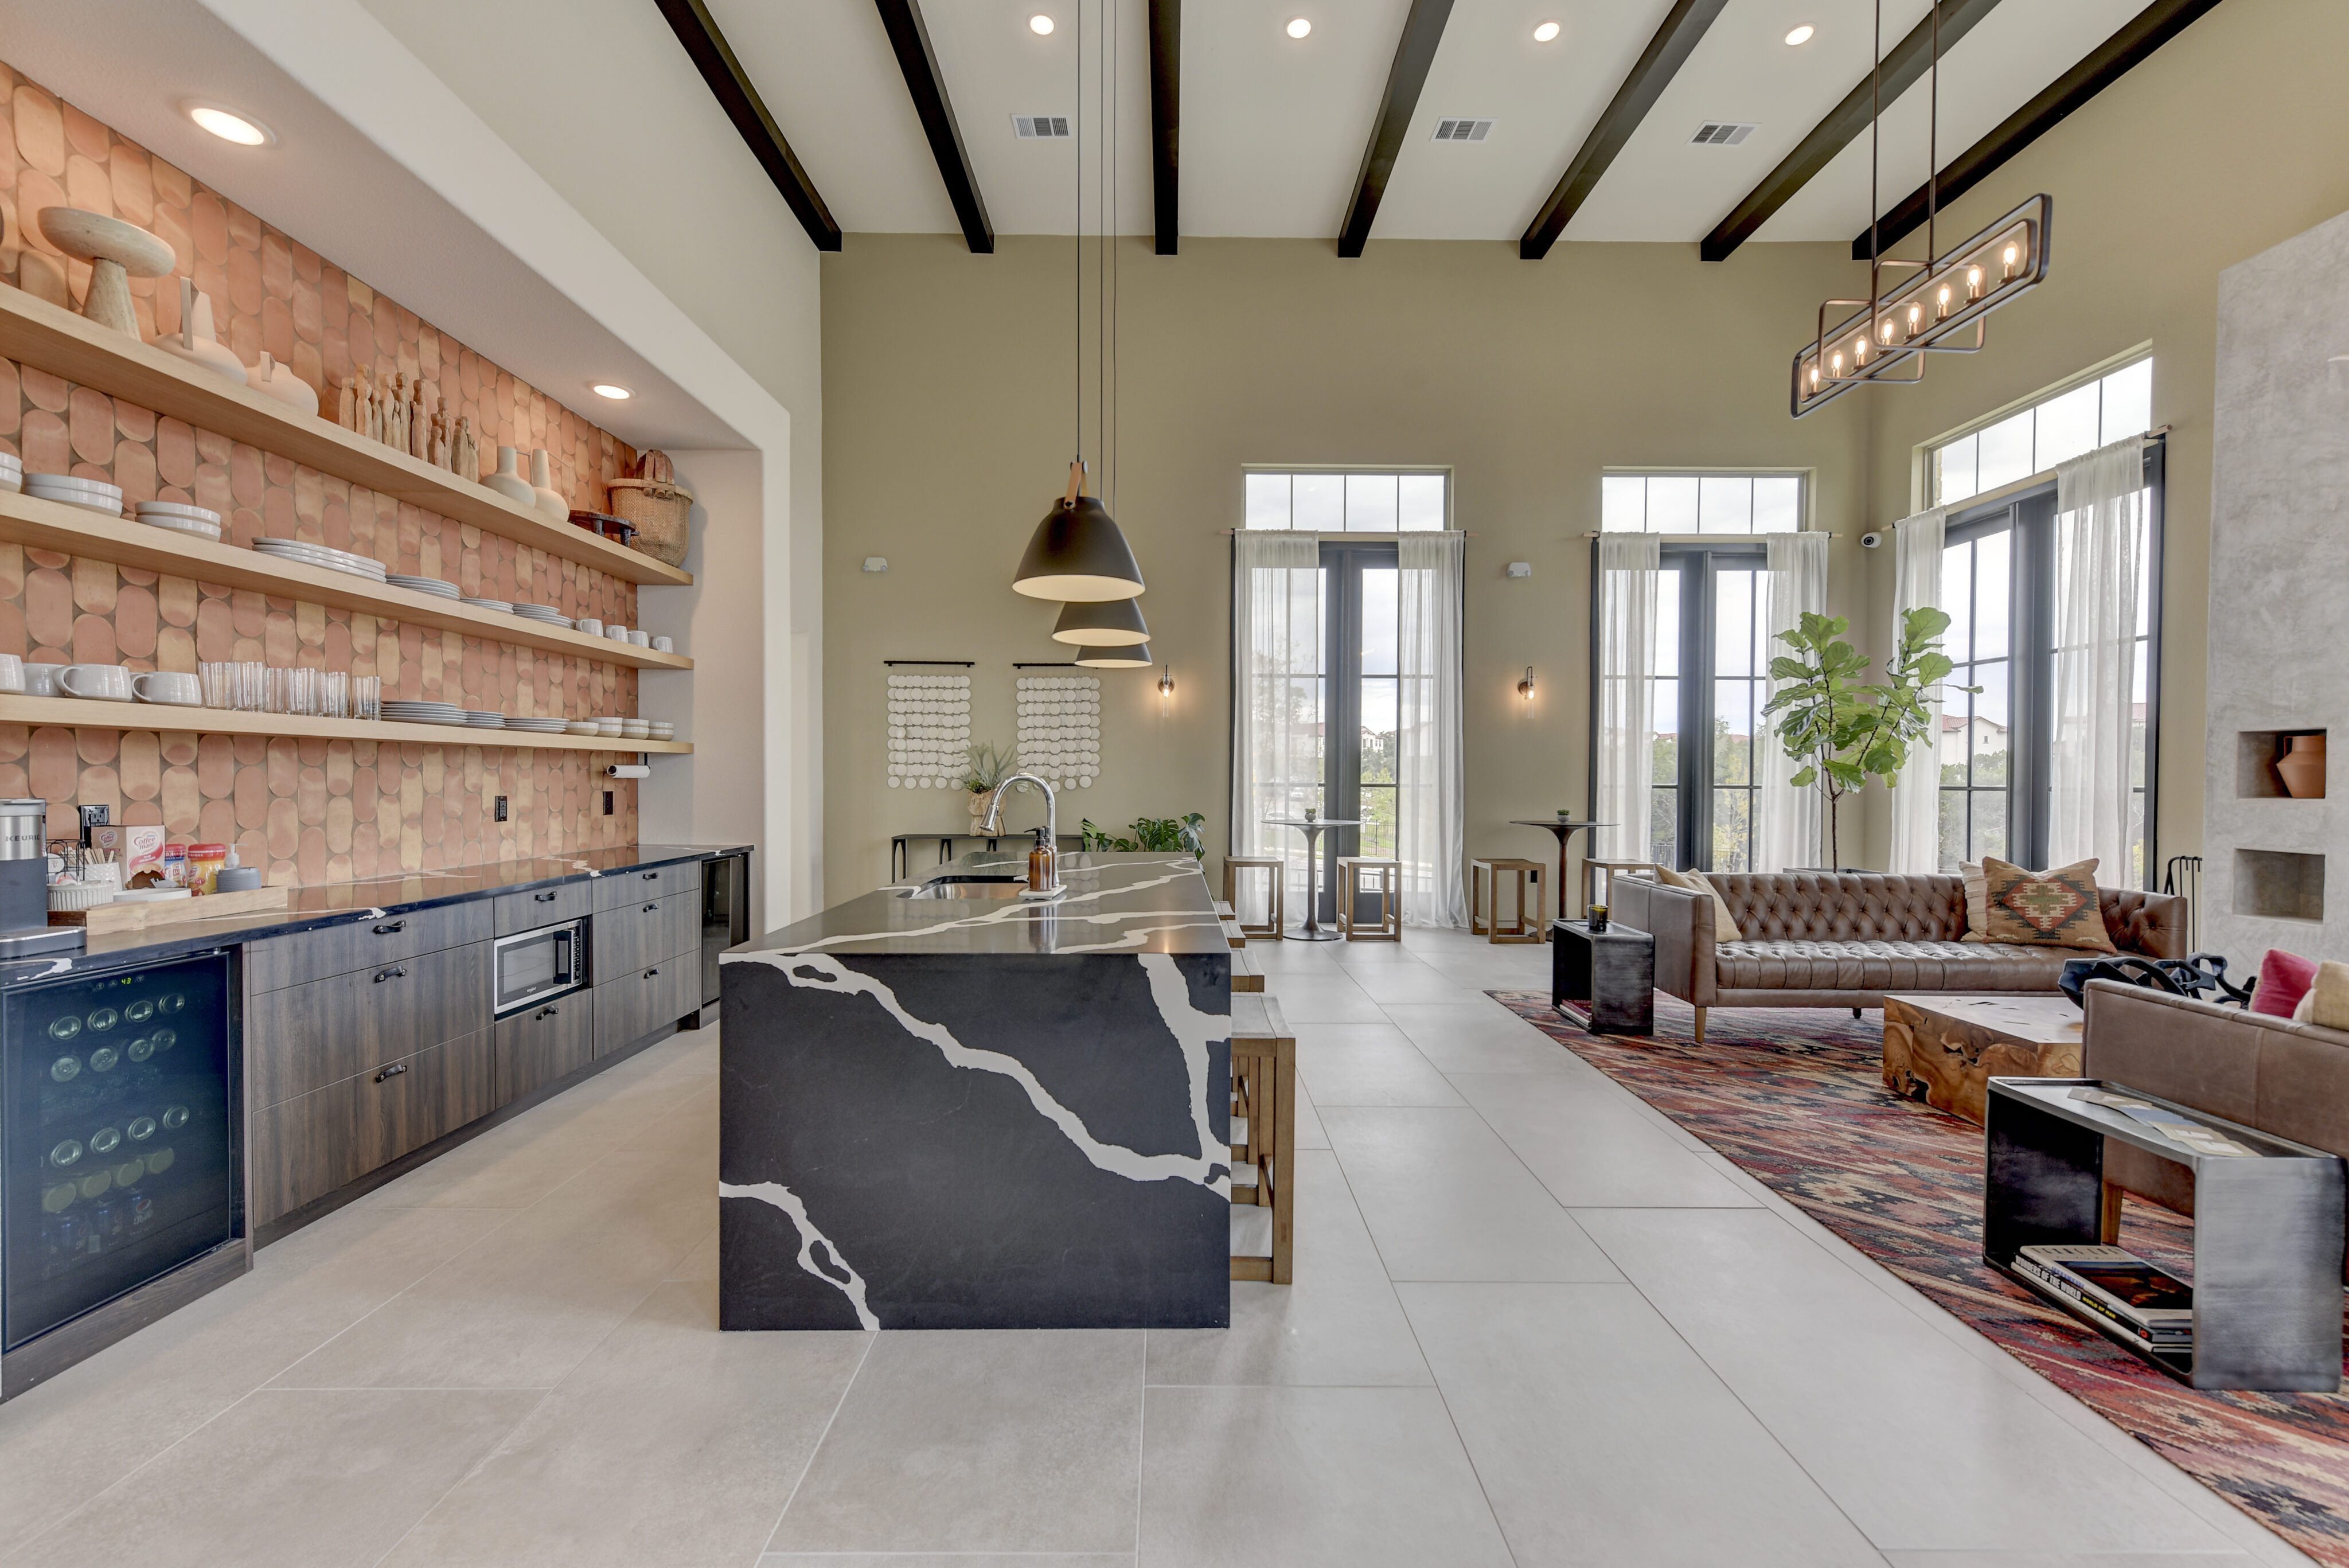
[385,1284,874,1568]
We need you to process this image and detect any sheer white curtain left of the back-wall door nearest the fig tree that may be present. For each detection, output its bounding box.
[1587,533,1661,865]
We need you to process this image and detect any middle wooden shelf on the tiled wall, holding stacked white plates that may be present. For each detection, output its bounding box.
[0,492,693,670]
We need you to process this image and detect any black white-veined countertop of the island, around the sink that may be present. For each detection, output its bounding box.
[721,851,1231,964]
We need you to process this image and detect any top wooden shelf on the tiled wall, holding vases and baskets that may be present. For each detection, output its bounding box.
[0,287,693,583]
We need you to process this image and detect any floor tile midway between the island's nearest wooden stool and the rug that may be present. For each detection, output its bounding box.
[1322,1105,1621,1281]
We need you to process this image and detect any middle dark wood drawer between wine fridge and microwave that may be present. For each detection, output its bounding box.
[244,943,491,1105]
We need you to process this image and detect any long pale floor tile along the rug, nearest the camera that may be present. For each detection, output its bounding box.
[1579,1208,2227,1551]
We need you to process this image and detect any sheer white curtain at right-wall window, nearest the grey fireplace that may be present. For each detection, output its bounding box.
[2048,437,2152,886]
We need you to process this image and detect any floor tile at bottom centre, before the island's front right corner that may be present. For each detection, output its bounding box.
[1137,1389,1511,1568]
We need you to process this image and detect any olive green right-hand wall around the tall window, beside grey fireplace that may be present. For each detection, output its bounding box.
[1851,0,2349,884]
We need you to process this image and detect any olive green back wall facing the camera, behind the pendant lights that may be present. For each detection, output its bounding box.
[822,235,1867,900]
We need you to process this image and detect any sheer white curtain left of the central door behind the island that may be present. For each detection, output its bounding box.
[1231,529,1322,907]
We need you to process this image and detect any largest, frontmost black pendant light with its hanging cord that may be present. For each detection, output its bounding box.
[1012,0,1149,606]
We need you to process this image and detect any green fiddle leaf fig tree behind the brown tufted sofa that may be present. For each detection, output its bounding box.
[1762,607,1980,865]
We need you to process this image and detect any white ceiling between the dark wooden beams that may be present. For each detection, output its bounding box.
[712,0,2145,242]
